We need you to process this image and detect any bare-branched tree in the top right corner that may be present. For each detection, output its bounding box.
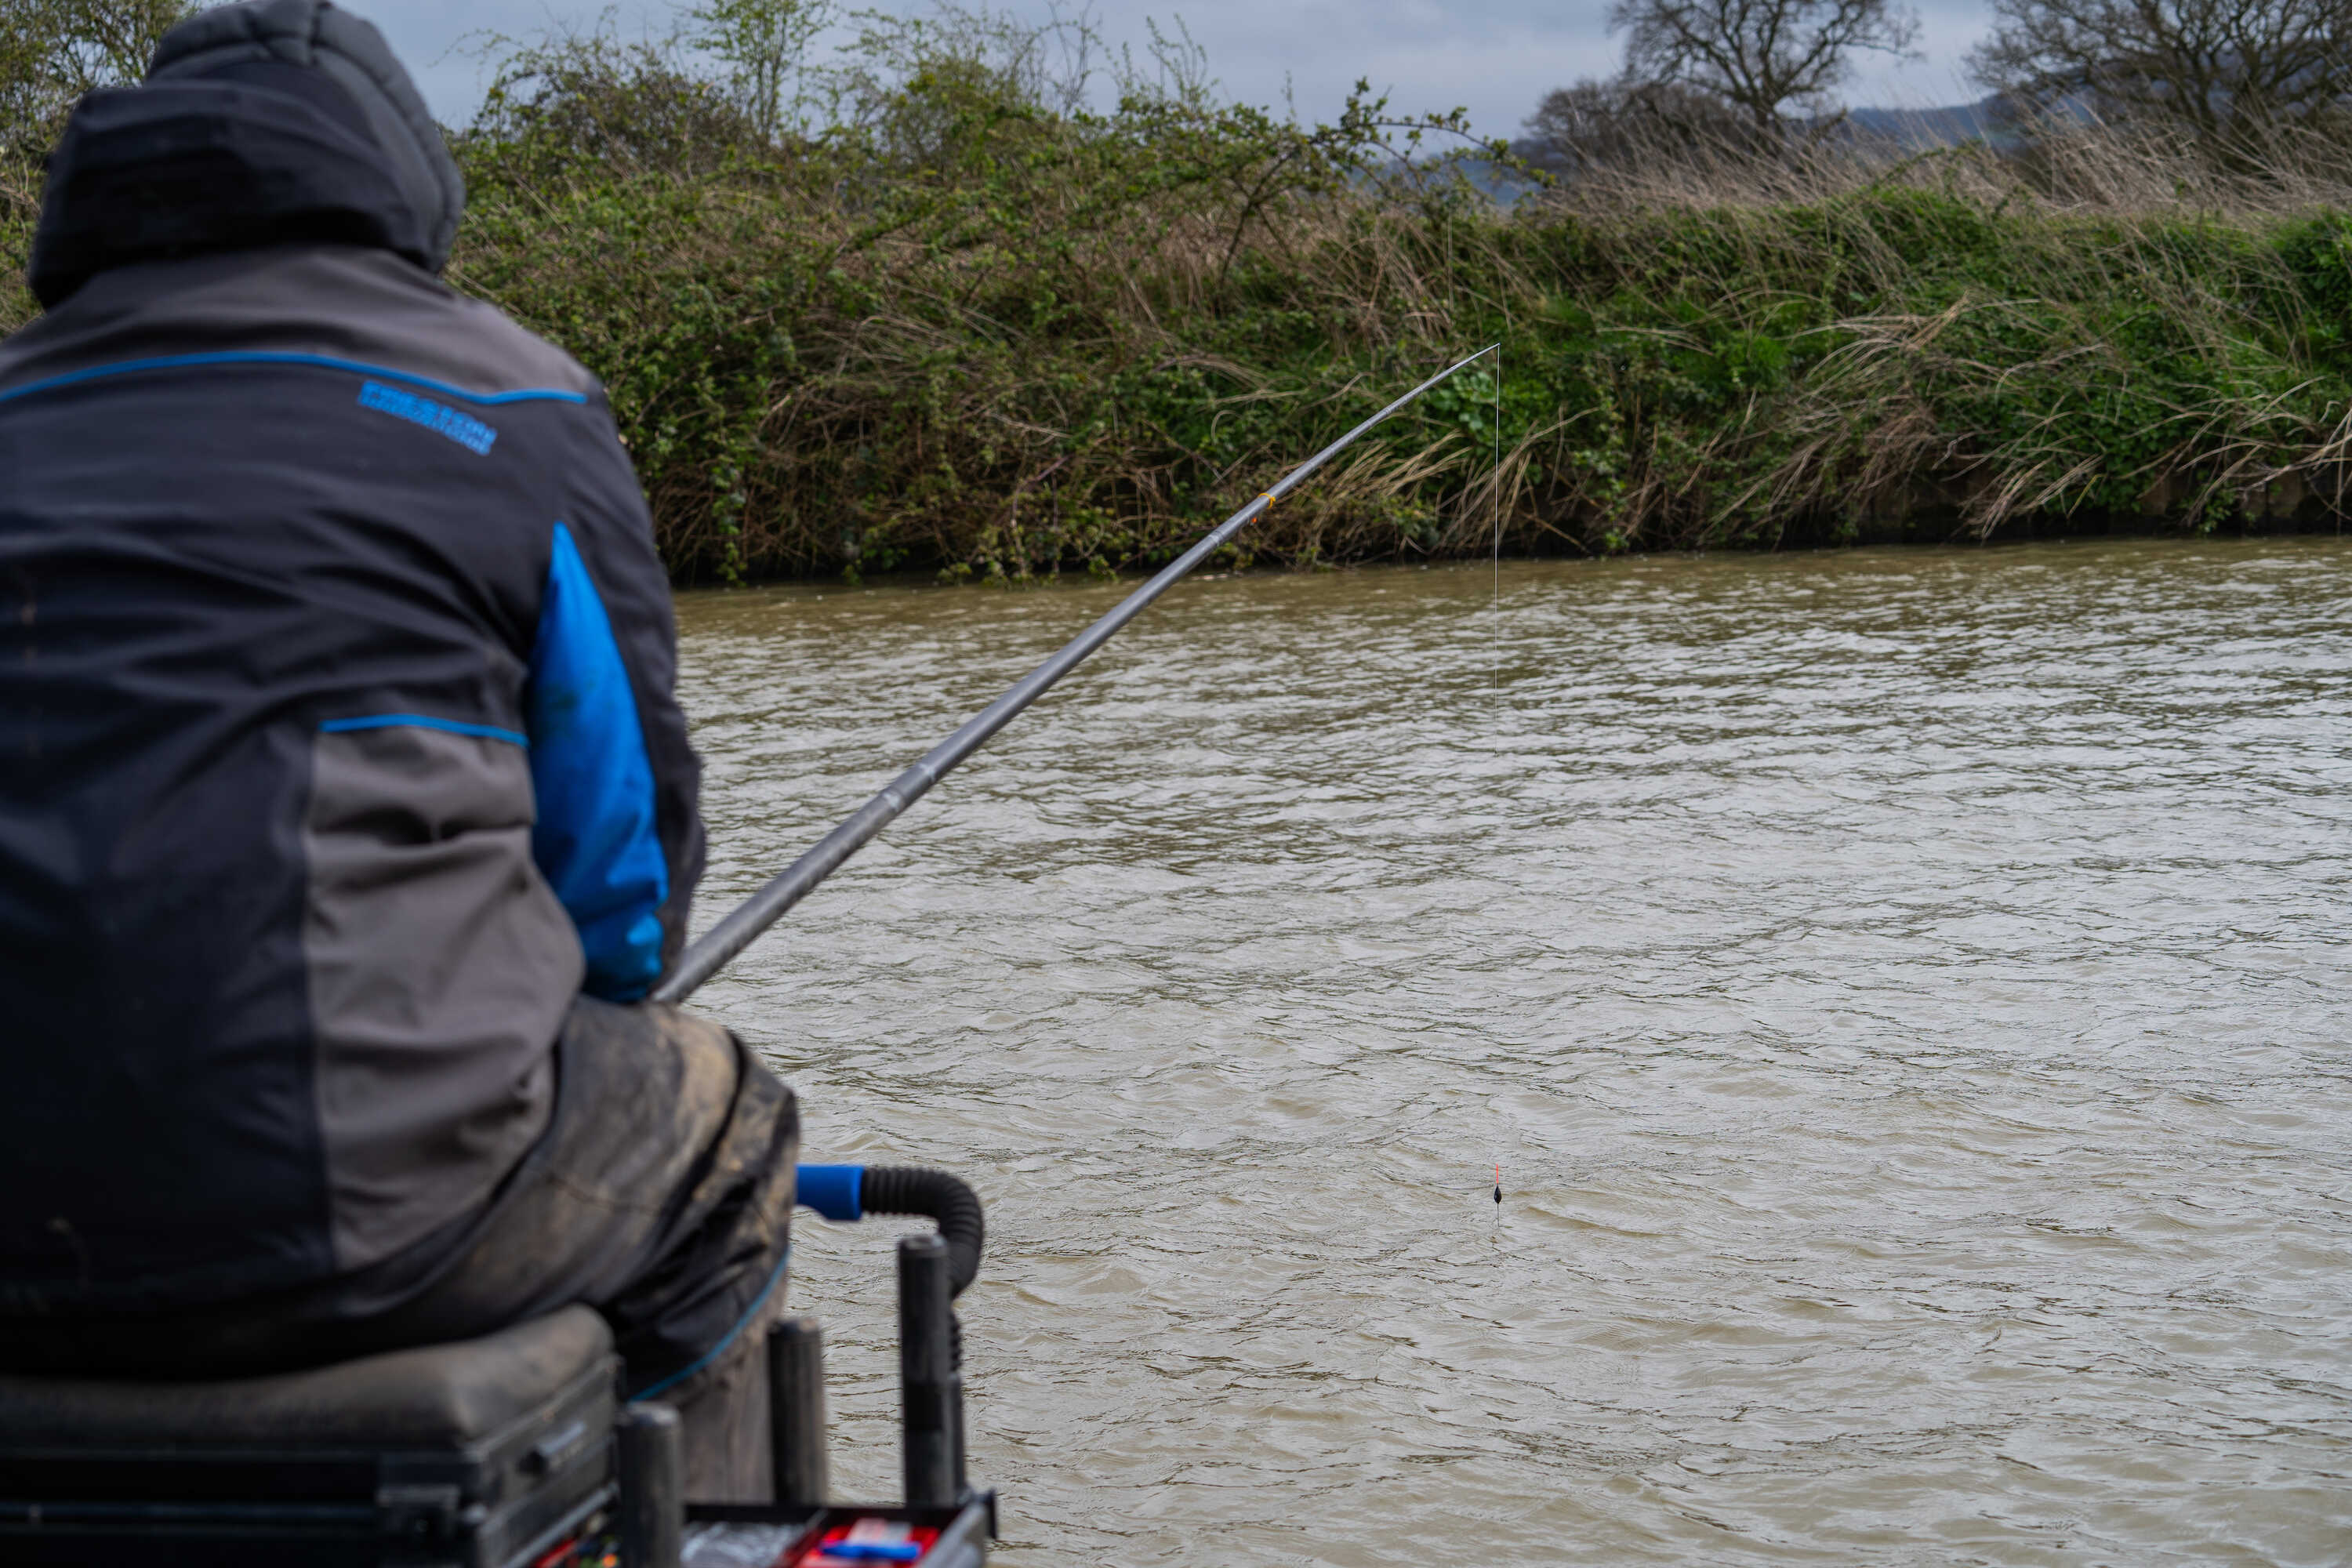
[1969,0,2352,146]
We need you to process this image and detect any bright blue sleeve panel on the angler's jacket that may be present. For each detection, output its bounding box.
[524,522,670,1001]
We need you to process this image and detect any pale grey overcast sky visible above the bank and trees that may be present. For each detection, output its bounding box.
[358,0,1985,136]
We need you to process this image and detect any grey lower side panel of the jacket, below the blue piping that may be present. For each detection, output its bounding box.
[303,724,581,1272]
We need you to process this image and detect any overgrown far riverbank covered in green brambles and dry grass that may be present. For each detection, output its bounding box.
[13,68,2352,583]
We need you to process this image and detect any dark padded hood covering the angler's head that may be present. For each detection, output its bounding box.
[31,0,466,306]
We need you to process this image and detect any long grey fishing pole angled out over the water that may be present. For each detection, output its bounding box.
[652,343,1501,1001]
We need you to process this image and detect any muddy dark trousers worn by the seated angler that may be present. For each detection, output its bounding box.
[0,996,800,1502]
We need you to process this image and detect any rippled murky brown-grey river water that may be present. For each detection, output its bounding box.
[680,541,2352,1566]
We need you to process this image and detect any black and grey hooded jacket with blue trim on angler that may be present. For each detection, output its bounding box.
[0,0,701,1316]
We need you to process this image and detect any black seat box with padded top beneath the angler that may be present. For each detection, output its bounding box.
[0,1307,619,1568]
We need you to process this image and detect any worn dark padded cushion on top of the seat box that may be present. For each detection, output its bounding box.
[0,1307,612,1450]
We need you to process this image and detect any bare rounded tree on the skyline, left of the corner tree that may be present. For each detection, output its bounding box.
[1609,0,1919,134]
